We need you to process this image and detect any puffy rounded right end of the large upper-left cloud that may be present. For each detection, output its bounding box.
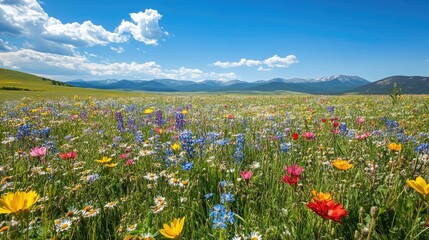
[117,9,168,45]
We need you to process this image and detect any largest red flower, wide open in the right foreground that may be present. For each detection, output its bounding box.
[306,199,347,223]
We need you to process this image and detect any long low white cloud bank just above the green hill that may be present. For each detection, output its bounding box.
[0,49,237,80]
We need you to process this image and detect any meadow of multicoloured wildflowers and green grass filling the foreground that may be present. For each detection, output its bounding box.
[0,95,429,240]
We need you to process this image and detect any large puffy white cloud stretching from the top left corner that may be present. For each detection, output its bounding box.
[0,0,168,55]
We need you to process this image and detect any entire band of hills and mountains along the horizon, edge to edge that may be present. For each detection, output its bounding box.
[0,68,429,94]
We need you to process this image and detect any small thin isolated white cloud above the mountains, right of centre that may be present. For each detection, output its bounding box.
[213,55,298,71]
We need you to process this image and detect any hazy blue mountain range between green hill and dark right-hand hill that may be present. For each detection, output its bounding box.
[67,75,370,94]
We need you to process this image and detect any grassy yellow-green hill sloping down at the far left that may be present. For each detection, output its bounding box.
[0,68,145,100]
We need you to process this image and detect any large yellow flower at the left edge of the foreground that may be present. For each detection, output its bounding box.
[0,191,39,214]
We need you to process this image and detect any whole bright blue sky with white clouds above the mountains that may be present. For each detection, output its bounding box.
[0,0,429,81]
